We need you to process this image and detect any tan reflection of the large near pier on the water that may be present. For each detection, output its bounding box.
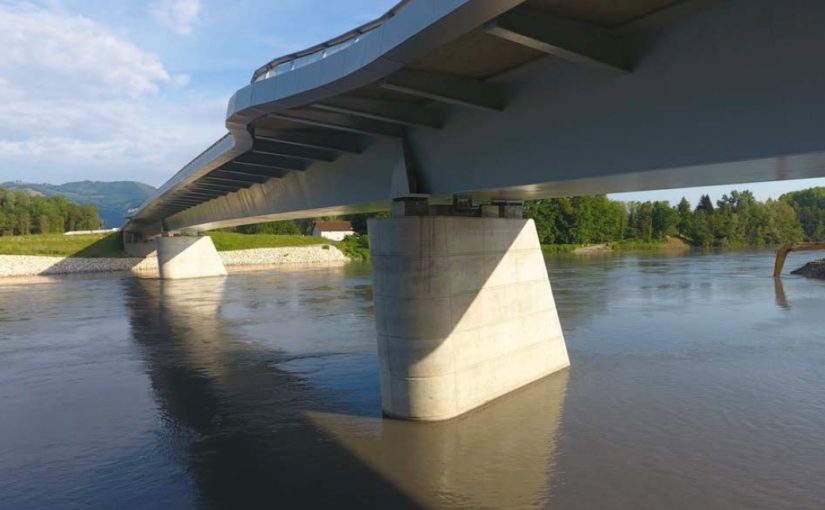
[307,370,568,508]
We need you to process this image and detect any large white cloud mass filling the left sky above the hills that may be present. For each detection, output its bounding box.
[0,3,225,185]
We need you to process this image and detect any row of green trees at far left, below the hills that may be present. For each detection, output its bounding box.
[0,188,100,236]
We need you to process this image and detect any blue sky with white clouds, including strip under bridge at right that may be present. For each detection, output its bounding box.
[0,0,825,207]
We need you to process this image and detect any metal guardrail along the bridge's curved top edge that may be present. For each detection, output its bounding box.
[251,0,412,83]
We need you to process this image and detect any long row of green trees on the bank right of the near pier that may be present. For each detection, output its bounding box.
[525,188,825,247]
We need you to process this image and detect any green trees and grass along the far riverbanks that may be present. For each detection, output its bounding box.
[0,184,825,272]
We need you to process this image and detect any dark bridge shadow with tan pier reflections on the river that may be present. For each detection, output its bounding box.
[122,278,567,508]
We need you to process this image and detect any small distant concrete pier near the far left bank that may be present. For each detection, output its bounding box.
[155,236,226,280]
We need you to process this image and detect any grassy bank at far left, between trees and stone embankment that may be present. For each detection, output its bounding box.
[0,232,125,258]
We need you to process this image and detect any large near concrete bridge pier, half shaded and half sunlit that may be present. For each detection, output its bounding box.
[369,216,570,420]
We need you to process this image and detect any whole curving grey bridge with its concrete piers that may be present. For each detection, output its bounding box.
[124,0,825,420]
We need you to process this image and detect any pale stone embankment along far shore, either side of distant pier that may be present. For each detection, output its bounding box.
[0,245,350,278]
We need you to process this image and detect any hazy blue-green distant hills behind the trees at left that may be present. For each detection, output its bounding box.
[0,181,155,228]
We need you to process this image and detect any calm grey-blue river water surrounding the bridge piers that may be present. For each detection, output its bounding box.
[0,251,825,510]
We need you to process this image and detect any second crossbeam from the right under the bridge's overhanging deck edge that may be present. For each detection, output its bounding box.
[380,69,504,111]
